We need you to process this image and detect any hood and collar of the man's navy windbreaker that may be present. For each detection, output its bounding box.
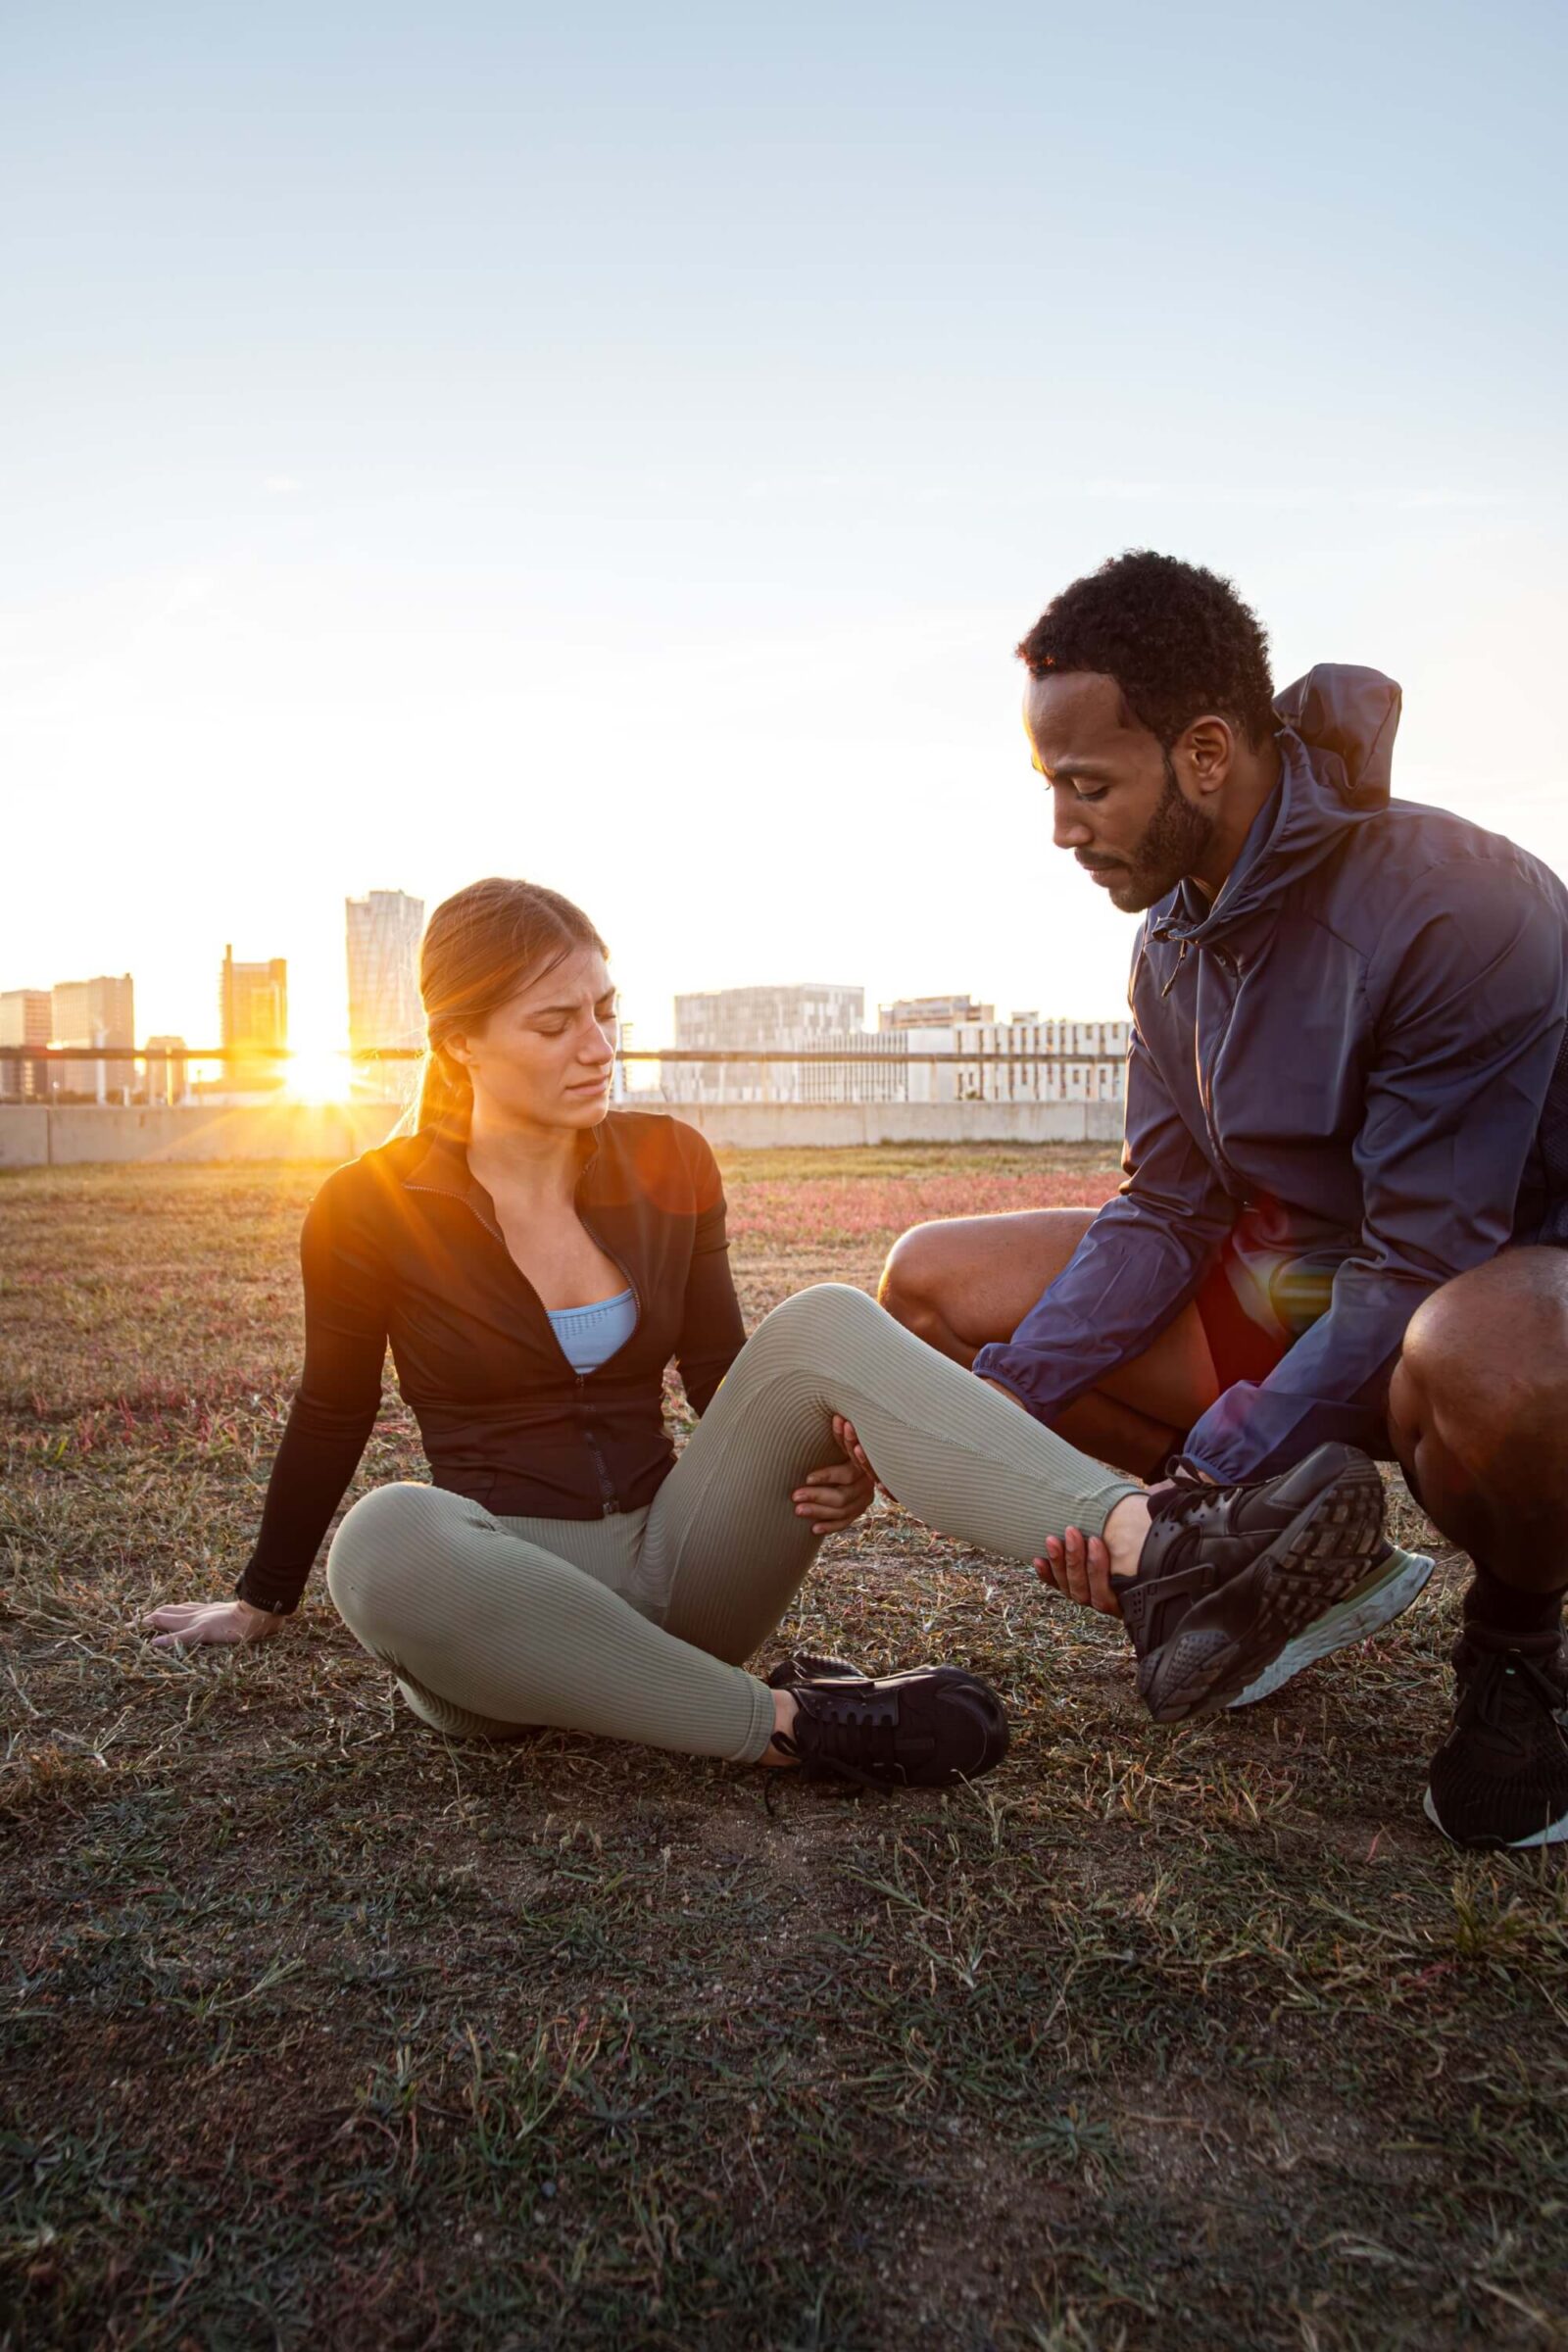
[1150,661,1401,941]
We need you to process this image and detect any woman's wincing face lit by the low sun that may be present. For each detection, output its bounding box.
[447,948,615,1127]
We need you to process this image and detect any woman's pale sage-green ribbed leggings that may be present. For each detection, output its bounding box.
[326,1282,1140,1764]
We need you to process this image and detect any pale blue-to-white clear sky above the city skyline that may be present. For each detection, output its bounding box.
[0,0,1568,1045]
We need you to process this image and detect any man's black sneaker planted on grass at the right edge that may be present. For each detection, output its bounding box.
[1425,1625,1568,1846]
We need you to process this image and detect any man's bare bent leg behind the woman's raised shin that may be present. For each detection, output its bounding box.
[877,1209,1220,1480]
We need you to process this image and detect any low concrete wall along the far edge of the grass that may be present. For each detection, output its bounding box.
[0,1103,1121,1169]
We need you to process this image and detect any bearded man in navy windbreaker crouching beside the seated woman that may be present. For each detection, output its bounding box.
[882,553,1568,1846]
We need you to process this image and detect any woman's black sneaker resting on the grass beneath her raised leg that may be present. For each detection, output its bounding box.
[768,1658,1008,1788]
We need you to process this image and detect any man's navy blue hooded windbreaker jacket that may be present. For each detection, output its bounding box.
[976,665,1568,1480]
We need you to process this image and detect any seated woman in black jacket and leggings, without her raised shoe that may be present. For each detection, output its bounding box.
[146,880,1372,1788]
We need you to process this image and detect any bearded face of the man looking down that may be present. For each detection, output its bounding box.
[1022,670,1213,915]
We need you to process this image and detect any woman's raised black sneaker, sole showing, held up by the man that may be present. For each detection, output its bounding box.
[1114,1445,1385,1724]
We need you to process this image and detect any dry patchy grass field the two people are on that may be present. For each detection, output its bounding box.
[0,1151,1568,2352]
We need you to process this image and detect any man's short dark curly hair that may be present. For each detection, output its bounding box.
[1018,548,1279,751]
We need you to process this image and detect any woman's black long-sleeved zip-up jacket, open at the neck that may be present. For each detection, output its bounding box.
[237,1110,745,1611]
